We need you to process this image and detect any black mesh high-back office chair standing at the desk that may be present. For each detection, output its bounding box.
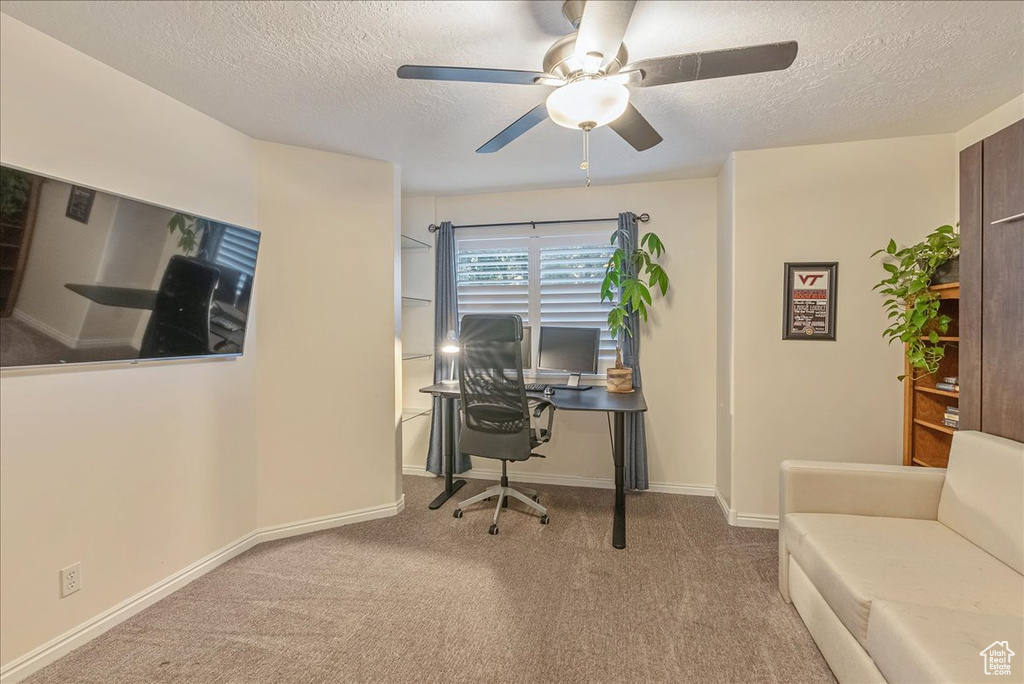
[454,313,554,535]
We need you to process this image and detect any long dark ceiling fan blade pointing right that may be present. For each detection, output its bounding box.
[623,41,797,88]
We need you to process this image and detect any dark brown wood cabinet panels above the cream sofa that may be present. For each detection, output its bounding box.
[959,120,1024,441]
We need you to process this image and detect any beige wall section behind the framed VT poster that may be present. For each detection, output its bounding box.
[732,135,955,518]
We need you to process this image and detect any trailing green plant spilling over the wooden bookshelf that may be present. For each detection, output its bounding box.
[871,225,959,381]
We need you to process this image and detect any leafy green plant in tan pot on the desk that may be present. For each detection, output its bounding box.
[601,228,669,392]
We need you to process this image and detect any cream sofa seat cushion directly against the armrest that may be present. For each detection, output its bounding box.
[783,513,1024,647]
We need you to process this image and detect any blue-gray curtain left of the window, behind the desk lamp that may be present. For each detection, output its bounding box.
[427,221,471,475]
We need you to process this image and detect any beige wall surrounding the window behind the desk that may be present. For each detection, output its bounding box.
[403,178,717,487]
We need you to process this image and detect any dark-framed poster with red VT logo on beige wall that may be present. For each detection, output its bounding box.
[782,261,839,342]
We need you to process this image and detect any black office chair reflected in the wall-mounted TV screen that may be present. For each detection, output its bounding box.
[138,254,220,358]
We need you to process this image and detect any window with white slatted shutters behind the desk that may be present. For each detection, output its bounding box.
[456,227,615,373]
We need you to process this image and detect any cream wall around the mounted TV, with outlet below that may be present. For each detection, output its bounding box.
[0,14,256,664]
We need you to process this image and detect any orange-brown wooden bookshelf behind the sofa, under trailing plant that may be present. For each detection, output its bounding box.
[903,283,959,468]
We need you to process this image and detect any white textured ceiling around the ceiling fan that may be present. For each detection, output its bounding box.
[0,0,1024,195]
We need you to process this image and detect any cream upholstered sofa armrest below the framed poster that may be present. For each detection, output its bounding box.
[778,461,946,520]
